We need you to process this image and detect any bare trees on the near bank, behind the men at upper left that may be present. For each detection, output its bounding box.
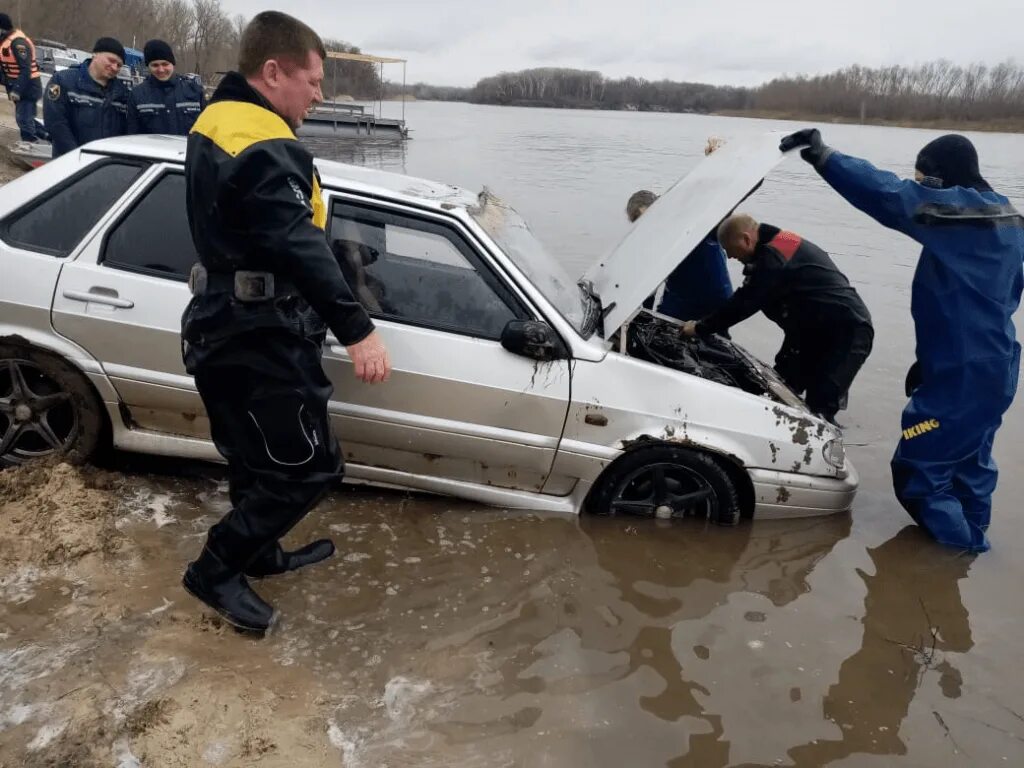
[12,0,381,96]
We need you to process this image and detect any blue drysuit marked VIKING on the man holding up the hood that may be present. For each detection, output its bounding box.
[818,152,1024,552]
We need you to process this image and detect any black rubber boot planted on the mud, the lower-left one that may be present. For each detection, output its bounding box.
[181,547,274,632]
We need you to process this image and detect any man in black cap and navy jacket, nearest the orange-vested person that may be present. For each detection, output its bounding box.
[43,37,129,158]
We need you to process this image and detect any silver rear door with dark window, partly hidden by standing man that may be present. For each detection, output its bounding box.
[52,167,209,437]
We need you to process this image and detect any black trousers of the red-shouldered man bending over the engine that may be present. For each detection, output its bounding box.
[775,324,874,419]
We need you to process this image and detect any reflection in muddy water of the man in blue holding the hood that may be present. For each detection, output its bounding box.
[790,525,974,767]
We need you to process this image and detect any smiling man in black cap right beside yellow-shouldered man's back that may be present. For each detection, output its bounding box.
[128,40,206,136]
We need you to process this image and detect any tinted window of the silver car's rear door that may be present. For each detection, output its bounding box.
[100,173,199,280]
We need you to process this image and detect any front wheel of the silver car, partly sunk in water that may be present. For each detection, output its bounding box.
[586,444,740,525]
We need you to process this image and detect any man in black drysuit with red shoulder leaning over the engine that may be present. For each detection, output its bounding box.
[683,214,874,423]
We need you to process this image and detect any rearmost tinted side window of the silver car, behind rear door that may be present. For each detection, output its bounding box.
[0,162,143,256]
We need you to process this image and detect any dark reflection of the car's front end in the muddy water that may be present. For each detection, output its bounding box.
[583,515,850,767]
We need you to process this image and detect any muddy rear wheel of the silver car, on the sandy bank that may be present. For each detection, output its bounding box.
[0,344,106,467]
